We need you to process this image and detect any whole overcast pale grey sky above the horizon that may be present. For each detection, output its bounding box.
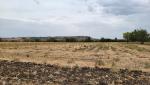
[0,0,150,38]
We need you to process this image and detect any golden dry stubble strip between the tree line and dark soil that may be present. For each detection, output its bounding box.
[0,42,150,72]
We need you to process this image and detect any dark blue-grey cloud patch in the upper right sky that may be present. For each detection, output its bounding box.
[85,0,150,15]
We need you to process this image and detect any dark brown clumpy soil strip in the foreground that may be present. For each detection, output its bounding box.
[0,61,150,85]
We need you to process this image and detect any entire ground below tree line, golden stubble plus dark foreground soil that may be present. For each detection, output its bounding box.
[0,42,150,85]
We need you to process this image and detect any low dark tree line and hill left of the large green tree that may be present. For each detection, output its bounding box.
[0,37,125,42]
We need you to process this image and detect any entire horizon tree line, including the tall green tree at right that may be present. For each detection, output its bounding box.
[0,29,150,44]
